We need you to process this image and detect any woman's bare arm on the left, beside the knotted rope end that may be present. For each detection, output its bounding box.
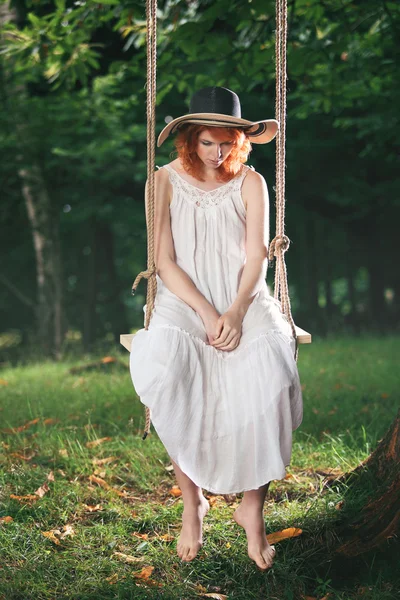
[145,169,215,317]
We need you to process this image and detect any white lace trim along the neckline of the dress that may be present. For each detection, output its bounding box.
[163,165,251,209]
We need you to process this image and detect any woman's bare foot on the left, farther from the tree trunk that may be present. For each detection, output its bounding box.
[177,496,210,562]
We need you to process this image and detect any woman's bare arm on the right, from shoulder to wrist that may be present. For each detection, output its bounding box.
[231,171,269,317]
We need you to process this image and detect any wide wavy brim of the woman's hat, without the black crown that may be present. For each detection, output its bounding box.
[157,113,279,147]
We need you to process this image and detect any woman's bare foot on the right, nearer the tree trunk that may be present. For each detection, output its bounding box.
[233,505,275,571]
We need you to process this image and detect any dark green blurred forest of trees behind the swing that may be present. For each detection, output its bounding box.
[0,0,400,361]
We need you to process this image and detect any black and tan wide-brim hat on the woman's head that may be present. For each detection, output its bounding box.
[157,86,279,146]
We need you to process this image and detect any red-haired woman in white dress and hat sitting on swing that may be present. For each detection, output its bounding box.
[130,87,302,570]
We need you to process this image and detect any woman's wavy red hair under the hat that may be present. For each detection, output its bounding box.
[174,123,251,181]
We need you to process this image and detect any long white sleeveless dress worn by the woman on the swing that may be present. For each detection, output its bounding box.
[130,165,303,494]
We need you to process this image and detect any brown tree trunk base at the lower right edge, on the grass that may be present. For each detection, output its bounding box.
[335,411,400,557]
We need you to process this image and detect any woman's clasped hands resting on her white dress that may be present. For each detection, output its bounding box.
[202,307,245,351]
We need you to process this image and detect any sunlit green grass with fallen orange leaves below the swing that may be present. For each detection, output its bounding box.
[0,337,400,600]
